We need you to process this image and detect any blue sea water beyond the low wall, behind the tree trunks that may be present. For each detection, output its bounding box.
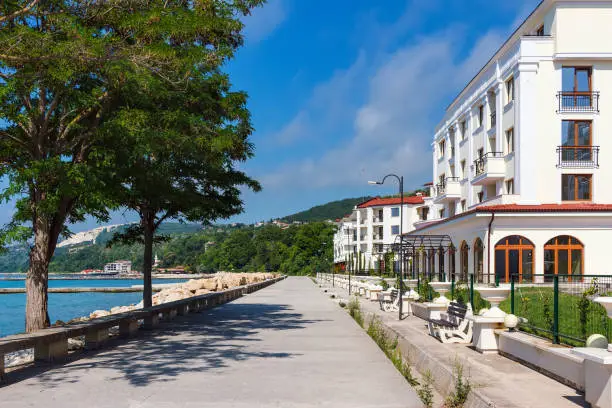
[0,274,186,337]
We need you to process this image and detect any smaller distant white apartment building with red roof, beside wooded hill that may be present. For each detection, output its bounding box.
[334,195,425,271]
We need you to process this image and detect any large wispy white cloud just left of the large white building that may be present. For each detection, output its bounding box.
[261,30,501,189]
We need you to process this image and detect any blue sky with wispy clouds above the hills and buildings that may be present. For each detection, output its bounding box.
[0,0,539,231]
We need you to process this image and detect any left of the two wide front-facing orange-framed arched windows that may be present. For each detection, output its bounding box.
[495,235,535,283]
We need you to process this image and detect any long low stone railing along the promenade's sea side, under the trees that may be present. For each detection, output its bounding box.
[0,276,285,383]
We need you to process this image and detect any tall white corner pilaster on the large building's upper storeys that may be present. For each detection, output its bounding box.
[514,63,539,204]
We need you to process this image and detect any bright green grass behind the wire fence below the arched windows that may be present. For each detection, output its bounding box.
[500,287,612,346]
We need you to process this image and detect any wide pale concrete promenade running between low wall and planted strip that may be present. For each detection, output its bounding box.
[0,278,421,408]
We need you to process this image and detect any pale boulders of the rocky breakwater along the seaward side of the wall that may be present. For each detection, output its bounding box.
[5,272,279,367]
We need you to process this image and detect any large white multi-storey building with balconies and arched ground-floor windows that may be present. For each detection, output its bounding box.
[411,0,612,282]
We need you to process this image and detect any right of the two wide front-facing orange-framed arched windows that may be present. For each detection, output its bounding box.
[544,235,584,281]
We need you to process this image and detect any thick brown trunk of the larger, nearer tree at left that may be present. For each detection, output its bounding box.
[26,219,52,333]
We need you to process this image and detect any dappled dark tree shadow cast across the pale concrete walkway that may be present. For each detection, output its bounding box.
[4,303,322,389]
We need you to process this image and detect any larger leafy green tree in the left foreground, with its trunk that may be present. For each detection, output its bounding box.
[0,0,263,331]
